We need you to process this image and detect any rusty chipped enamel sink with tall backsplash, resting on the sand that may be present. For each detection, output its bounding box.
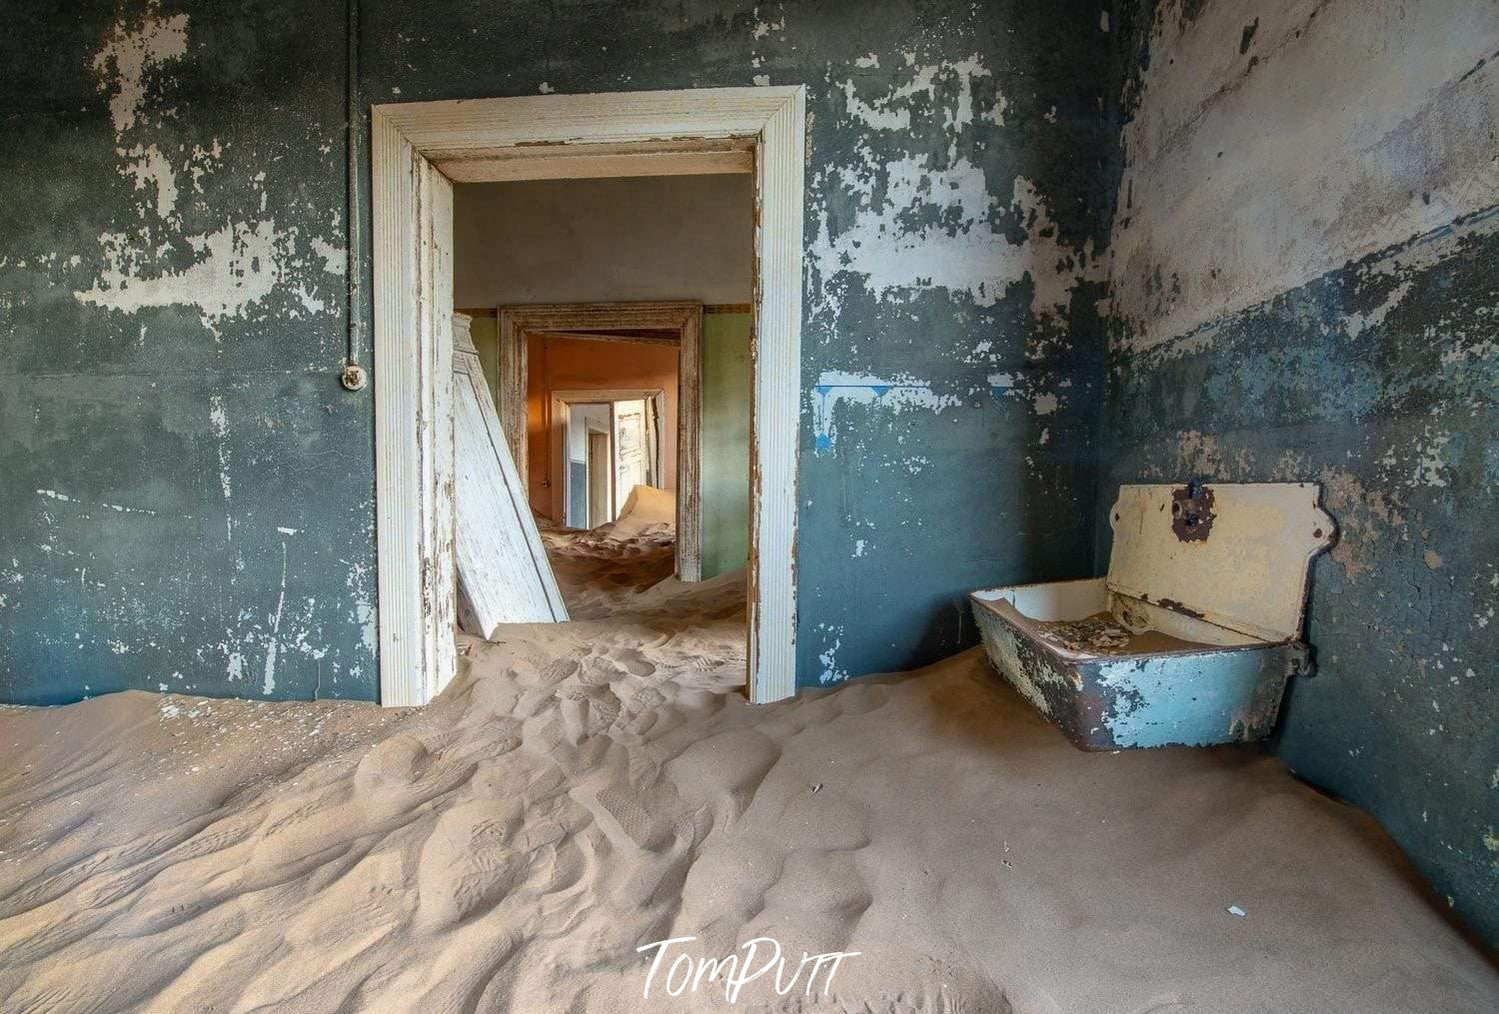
[970,483,1336,750]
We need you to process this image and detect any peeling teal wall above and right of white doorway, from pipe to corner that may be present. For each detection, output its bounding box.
[361,0,1109,683]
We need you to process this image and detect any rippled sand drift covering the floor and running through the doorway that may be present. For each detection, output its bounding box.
[0,533,1499,1014]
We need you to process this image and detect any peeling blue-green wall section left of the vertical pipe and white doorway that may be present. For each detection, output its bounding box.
[0,2,376,702]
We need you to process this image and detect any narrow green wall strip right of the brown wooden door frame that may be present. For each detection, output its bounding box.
[702,314,754,578]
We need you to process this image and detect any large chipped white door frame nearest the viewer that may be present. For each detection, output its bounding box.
[370,86,806,707]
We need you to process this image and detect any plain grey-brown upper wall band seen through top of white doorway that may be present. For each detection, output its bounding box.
[453,176,754,308]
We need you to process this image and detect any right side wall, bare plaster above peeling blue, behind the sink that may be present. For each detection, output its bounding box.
[1099,0,1499,941]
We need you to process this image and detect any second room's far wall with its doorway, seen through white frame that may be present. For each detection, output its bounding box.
[454,167,754,648]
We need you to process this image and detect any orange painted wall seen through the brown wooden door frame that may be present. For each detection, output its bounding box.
[526,338,676,521]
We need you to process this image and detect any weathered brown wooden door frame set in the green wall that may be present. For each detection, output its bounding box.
[495,302,703,582]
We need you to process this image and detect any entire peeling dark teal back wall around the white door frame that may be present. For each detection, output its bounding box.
[0,0,1109,702]
